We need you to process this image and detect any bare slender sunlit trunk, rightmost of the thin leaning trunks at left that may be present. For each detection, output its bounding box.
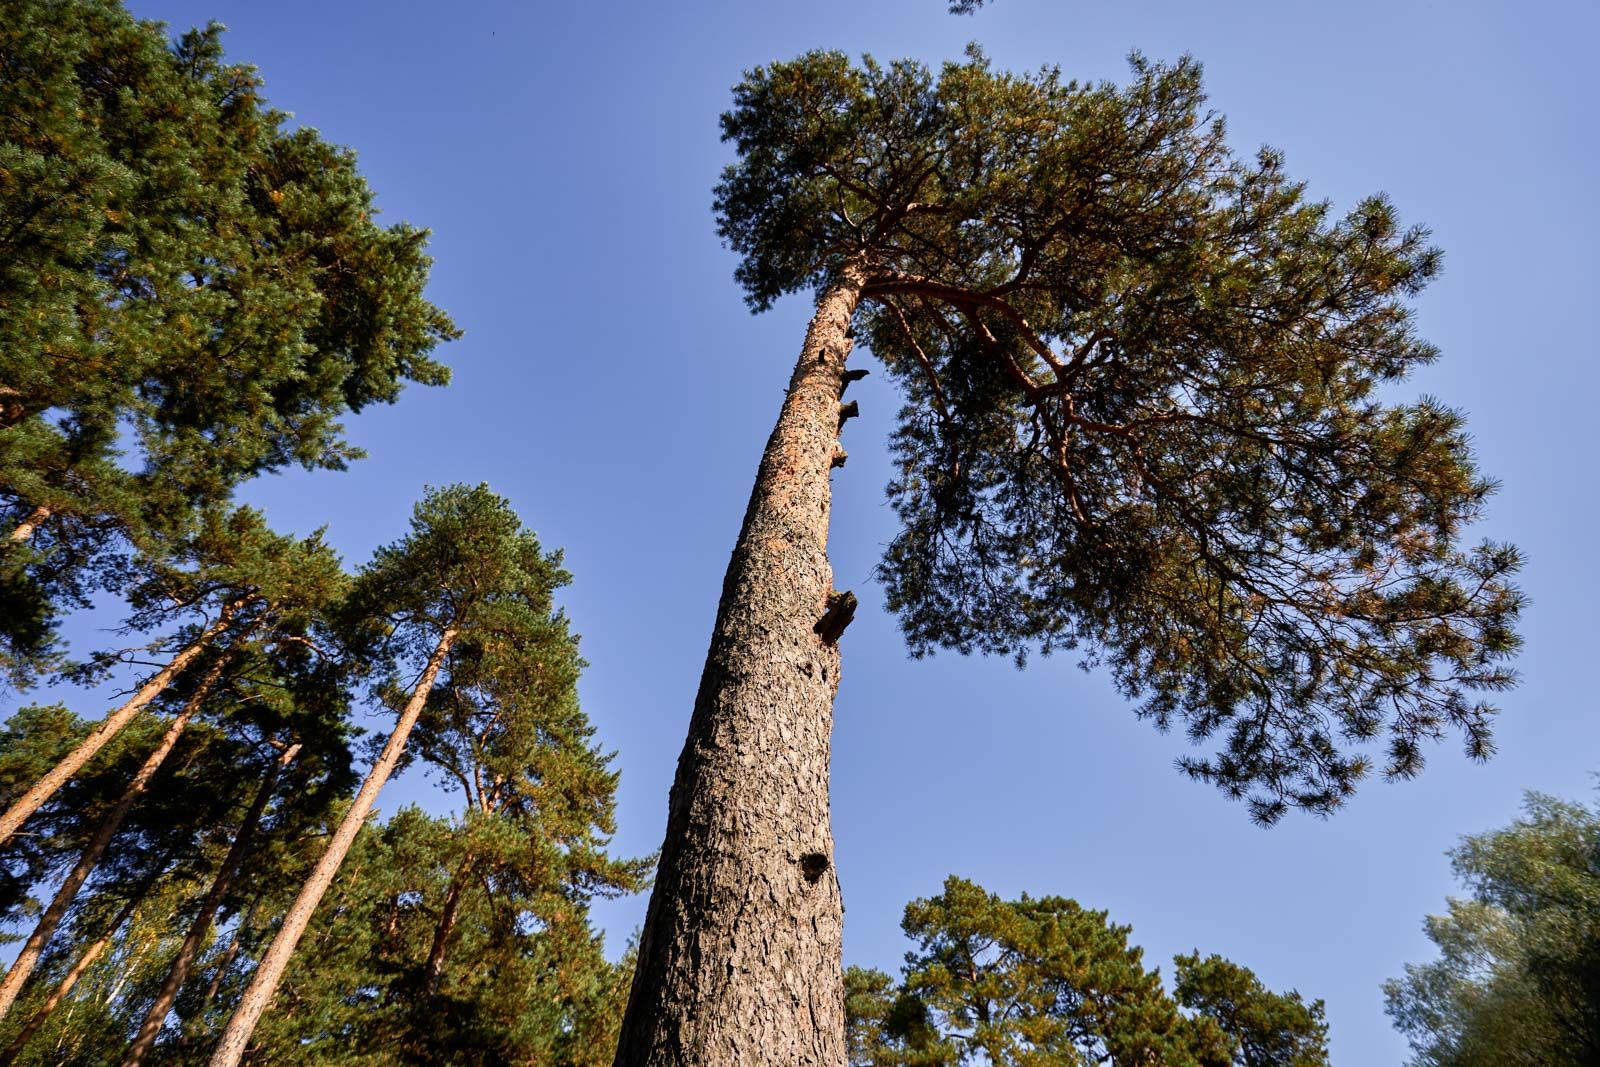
[211,627,456,1067]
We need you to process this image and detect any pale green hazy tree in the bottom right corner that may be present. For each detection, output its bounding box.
[1384,793,1600,1067]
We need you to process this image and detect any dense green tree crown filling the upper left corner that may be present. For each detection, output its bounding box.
[0,0,456,680]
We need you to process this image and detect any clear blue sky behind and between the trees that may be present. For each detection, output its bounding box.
[75,0,1600,1064]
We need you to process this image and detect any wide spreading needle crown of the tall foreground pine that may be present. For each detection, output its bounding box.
[715,50,1522,822]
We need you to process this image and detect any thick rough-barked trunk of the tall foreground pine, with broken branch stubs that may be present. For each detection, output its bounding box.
[616,260,862,1067]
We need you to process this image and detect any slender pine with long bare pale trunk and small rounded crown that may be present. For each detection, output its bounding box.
[211,485,576,1067]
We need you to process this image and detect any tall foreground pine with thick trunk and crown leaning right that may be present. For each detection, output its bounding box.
[618,51,1520,1067]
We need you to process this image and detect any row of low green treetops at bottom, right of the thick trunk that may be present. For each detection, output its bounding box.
[845,877,1328,1067]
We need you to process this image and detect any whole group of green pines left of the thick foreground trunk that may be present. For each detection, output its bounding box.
[0,2,648,1065]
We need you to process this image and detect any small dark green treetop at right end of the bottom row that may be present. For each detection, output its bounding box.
[1173,952,1328,1067]
